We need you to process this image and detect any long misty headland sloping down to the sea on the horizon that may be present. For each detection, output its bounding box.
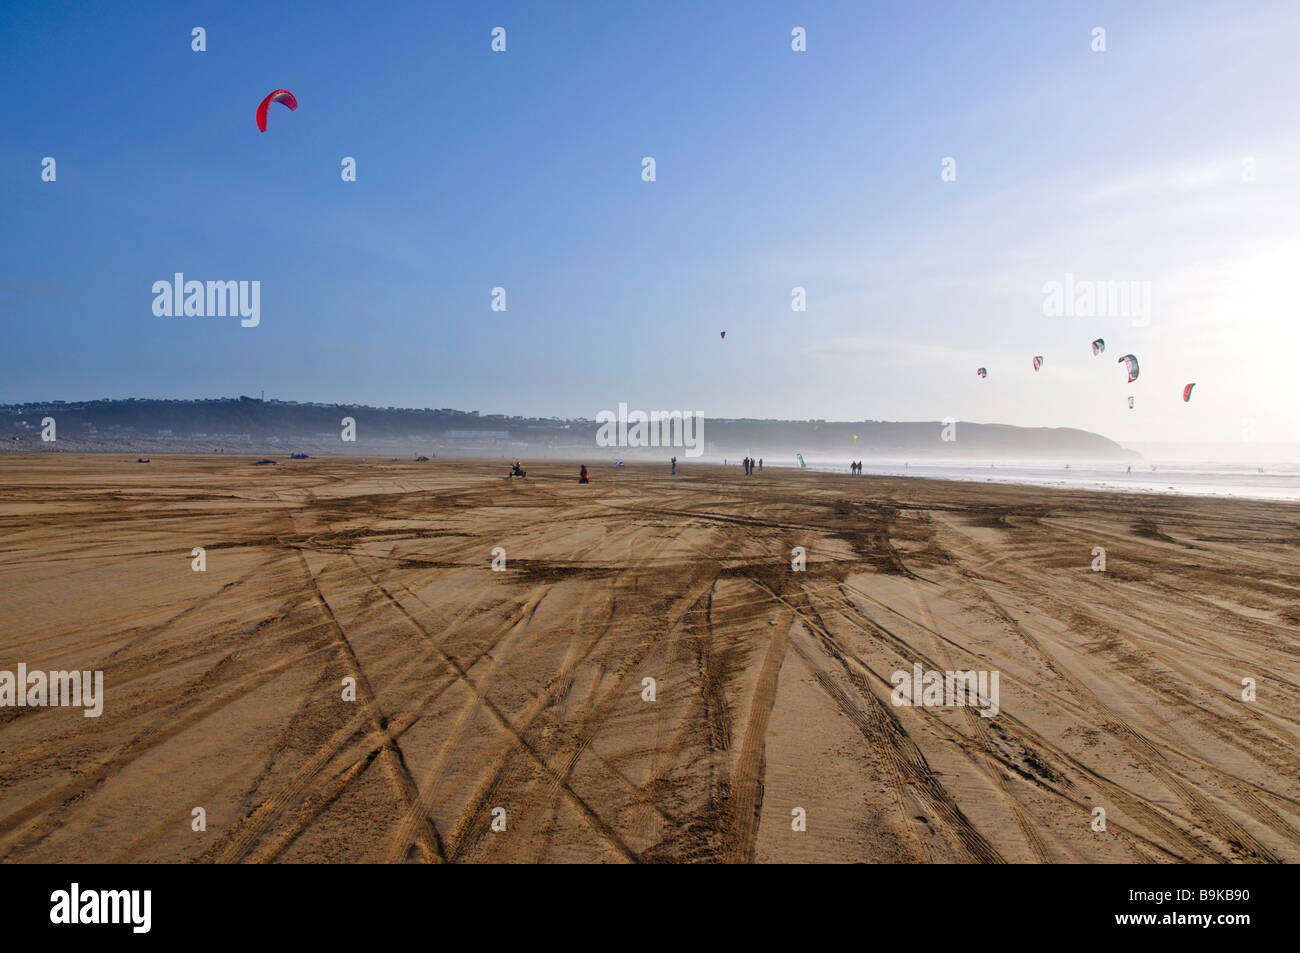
[0,397,1139,462]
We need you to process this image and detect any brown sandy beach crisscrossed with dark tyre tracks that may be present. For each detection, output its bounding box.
[0,454,1300,863]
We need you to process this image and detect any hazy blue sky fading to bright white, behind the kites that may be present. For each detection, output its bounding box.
[0,0,1300,442]
